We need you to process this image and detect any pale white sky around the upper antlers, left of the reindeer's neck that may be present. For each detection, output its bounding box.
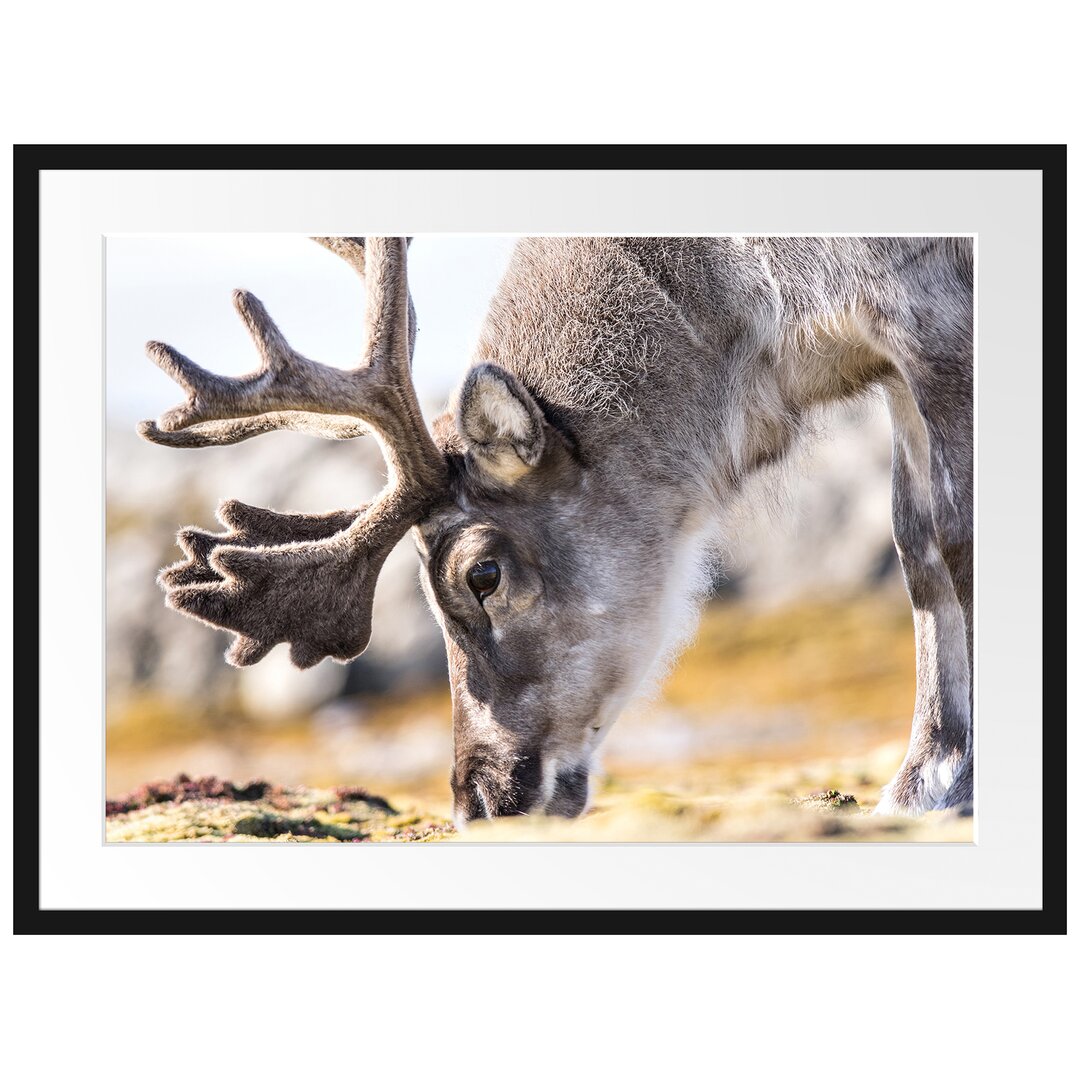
[106,233,514,423]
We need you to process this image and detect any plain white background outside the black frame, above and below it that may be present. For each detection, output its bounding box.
[2,2,1076,1077]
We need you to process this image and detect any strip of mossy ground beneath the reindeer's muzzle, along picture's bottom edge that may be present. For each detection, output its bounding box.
[106,755,973,843]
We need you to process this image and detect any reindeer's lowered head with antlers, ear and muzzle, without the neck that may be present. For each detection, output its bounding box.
[139,238,691,821]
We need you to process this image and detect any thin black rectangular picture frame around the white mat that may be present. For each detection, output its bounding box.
[12,145,1066,934]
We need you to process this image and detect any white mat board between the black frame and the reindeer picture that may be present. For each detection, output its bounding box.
[40,170,1042,909]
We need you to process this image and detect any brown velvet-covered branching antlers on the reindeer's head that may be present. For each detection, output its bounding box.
[138,237,447,667]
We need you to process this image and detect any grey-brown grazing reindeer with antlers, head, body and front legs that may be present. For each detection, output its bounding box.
[139,238,973,821]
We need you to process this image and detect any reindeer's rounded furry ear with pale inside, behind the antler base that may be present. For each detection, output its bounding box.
[454,364,546,484]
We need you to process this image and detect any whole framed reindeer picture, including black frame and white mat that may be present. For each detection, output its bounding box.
[15,146,1065,933]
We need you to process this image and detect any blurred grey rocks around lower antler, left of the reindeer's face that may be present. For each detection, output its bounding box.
[106,419,446,723]
